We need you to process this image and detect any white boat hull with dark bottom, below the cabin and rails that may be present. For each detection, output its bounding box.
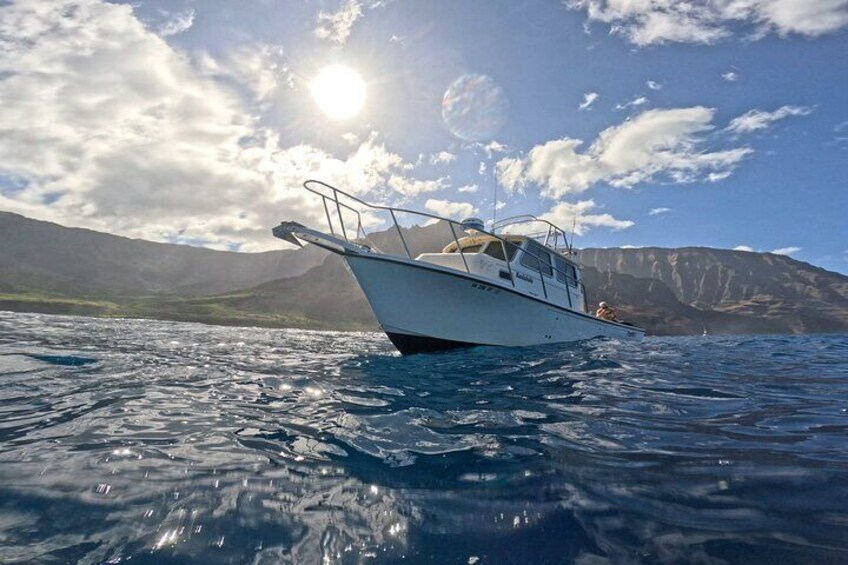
[344,253,644,354]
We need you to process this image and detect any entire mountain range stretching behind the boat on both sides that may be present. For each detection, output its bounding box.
[0,213,848,335]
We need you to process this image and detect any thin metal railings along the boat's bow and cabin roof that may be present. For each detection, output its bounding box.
[303,179,586,311]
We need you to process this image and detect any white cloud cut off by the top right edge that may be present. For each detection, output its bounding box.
[567,0,848,46]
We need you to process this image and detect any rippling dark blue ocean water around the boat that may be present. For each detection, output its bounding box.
[0,313,848,565]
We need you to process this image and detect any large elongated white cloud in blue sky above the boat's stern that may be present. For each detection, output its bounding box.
[495,106,752,199]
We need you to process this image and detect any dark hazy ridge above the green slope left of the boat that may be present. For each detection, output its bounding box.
[0,212,324,297]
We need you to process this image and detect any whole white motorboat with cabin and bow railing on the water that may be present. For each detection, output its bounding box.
[272,180,645,355]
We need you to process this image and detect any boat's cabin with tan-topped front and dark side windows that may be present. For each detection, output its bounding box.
[416,234,587,312]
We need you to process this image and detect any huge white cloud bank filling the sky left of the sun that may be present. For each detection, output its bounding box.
[0,0,444,250]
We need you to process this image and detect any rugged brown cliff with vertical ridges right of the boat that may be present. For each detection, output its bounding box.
[579,247,848,333]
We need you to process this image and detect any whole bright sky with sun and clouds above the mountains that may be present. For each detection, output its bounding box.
[0,0,848,273]
